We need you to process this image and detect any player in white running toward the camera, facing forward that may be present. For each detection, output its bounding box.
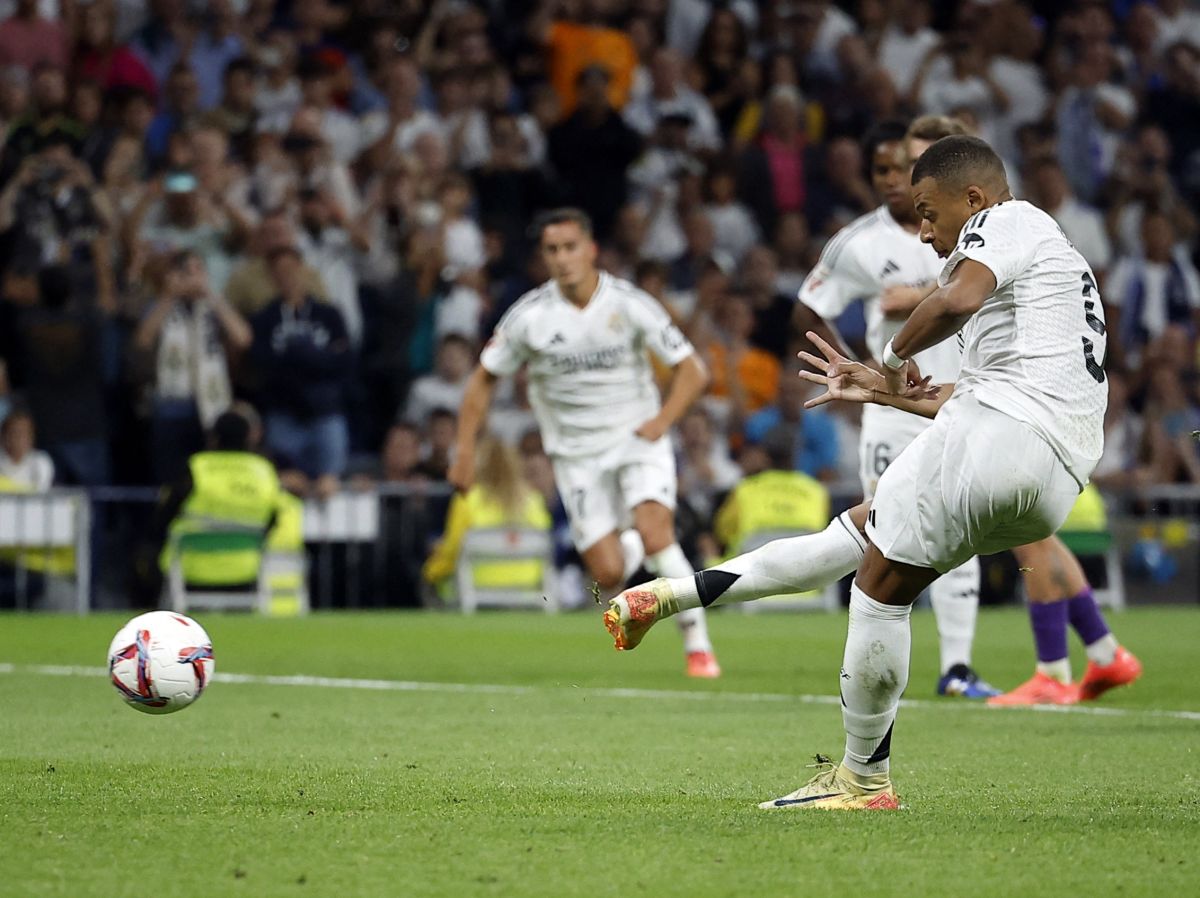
[449,209,720,677]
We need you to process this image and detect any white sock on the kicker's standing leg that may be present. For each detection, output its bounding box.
[841,581,912,776]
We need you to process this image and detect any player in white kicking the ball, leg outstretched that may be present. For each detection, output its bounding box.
[605,137,1123,809]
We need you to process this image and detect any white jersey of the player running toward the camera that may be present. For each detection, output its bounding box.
[480,271,692,457]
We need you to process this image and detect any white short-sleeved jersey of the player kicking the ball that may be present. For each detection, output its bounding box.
[938,200,1108,487]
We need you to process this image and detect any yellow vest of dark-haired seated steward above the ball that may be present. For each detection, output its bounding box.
[158,451,284,586]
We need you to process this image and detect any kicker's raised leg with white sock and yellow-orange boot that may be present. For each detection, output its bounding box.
[605,503,870,648]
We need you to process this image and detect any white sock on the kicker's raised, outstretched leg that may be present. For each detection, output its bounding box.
[670,511,866,610]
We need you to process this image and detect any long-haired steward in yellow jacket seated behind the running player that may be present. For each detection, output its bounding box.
[421,437,551,595]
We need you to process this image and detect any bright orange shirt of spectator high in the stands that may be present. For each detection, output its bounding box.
[529,0,637,116]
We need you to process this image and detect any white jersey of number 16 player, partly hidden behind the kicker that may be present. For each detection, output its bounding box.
[799,206,961,383]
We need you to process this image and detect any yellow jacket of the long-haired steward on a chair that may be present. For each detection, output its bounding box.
[421,486,551,589]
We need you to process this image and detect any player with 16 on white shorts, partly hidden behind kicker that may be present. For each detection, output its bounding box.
[798,115,1000,699]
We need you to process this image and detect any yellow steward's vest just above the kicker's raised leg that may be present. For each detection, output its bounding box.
[713,471,829,555]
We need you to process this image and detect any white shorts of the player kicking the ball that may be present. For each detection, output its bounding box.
[866,395,1079,574]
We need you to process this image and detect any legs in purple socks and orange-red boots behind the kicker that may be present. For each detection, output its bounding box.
[991,537,1141,705]
